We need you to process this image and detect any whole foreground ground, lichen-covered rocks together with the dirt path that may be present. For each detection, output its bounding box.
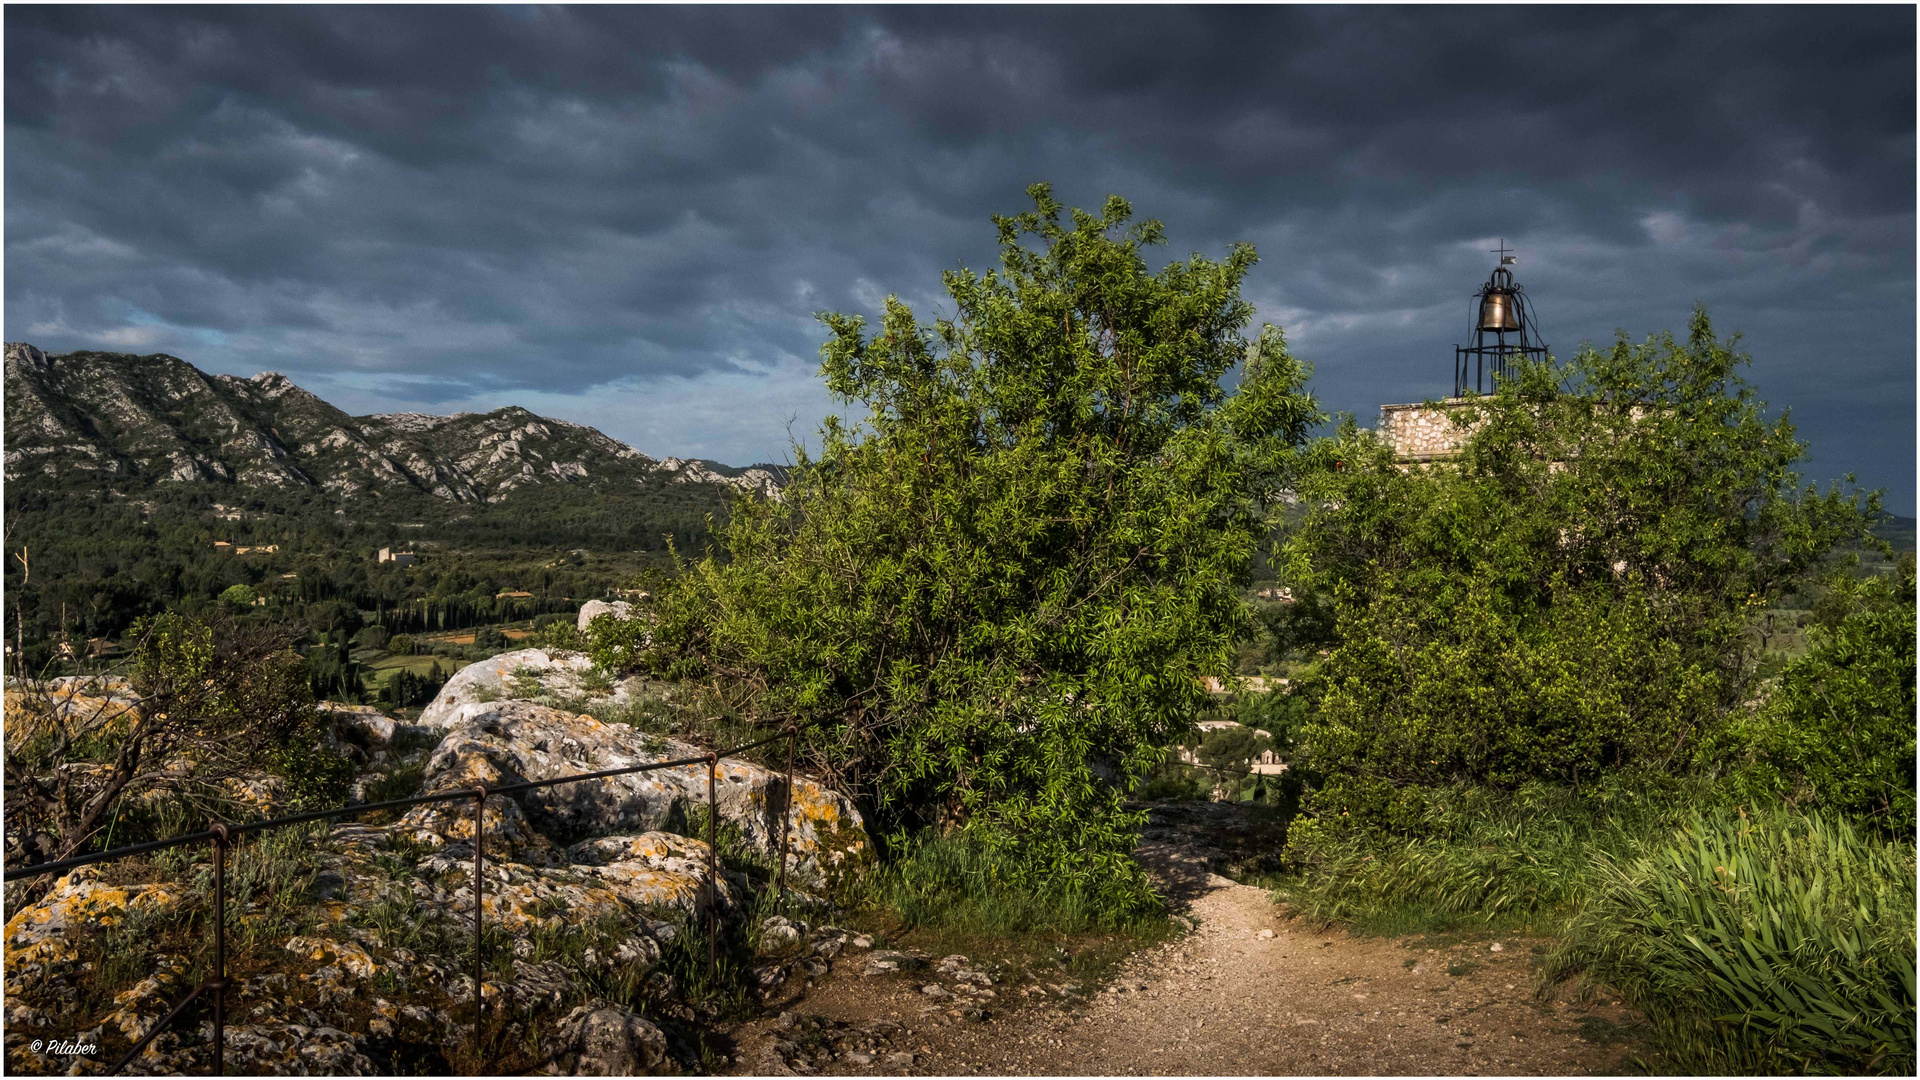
[4,650,1638,1074]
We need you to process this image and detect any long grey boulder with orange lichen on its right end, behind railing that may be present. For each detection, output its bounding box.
[420,701,872,888]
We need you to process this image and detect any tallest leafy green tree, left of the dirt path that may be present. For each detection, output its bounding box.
[629,184,1321,911]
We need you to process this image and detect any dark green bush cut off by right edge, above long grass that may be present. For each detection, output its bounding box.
[1724,555,1914,840]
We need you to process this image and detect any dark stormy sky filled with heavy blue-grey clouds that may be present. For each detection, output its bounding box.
[6,6,1914,513]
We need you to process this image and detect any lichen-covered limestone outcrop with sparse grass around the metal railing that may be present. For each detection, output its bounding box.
[4,650,872,1074]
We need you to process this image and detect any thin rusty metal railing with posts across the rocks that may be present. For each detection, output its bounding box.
[4,723,810,1076]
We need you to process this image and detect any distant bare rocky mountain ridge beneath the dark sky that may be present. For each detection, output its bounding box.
[6,342,783,503]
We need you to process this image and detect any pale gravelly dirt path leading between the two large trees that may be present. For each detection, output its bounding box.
[737,799,1638,1076]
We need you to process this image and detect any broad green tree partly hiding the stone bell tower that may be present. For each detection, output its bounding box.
[1286,311,1878,836]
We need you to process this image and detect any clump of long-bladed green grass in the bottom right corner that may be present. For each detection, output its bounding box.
[1549,811,1914,1076]
